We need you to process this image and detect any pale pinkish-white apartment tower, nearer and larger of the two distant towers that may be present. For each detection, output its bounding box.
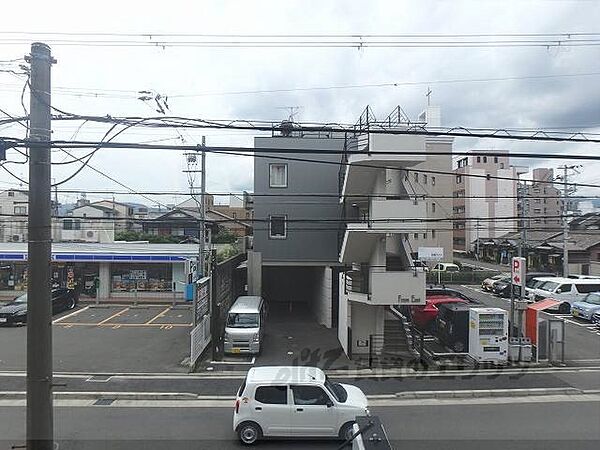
[453,151,522,253]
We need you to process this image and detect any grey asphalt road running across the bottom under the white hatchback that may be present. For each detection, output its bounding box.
[0,399,600,450]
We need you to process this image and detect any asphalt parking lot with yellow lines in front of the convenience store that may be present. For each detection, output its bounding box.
[0,305,192,373]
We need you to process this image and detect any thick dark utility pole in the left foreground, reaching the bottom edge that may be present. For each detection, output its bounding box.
[25,42,56,450]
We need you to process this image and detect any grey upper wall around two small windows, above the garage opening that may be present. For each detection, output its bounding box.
[254,137,344,265]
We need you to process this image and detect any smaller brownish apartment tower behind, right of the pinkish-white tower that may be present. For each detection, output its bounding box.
[518,168,562,231]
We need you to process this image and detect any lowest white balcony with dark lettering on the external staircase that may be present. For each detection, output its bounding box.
[344,265,425,305]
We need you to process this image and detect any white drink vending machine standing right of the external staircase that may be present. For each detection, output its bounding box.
[469,308,508,364]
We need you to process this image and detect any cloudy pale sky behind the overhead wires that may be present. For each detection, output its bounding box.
[0,0,600,204]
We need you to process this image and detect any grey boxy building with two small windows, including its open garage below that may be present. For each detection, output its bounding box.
[254,130,344,327]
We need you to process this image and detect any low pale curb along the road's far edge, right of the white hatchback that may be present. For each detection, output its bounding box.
[396,387,584,399]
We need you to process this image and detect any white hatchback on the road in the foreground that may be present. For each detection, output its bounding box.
[233,366,369,445]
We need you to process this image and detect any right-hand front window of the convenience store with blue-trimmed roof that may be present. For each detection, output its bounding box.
[111,264,173,292]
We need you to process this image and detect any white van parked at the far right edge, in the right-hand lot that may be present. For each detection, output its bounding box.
[531,277,600,314]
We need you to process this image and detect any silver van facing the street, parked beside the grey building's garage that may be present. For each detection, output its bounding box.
[223,295,266,354]
